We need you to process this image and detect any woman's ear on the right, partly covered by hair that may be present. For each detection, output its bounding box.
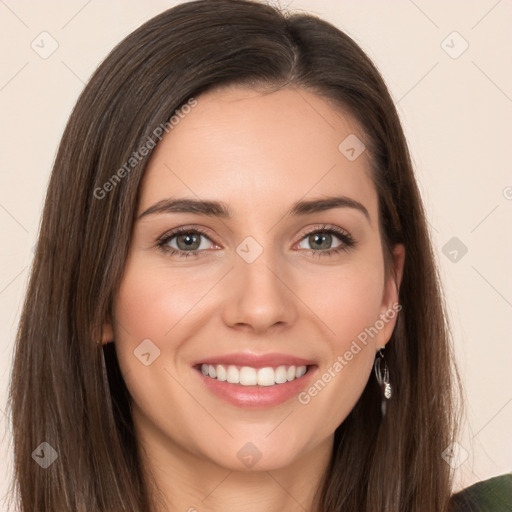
[377,244,405,348]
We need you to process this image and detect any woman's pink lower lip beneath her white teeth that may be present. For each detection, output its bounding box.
[195,366,317,408]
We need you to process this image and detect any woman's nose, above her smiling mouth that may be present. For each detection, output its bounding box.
[222,251,298,334]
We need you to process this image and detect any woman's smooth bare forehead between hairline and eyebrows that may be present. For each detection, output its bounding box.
[139,87,376,217]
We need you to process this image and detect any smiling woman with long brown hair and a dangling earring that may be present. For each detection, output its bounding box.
[7,0,508,512]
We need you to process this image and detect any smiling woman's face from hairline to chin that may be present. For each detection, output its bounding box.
[104,88,403,470]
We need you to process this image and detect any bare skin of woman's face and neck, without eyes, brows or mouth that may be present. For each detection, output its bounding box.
[103,87,404,512]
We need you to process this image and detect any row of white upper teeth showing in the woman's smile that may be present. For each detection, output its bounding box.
[201,364,307,386]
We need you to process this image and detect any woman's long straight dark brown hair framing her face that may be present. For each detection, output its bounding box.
[10,0,460,512]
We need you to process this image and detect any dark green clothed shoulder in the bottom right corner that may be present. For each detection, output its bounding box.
[450,473,512,512]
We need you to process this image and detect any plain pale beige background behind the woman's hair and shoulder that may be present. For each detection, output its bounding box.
[0,0,512,503]
